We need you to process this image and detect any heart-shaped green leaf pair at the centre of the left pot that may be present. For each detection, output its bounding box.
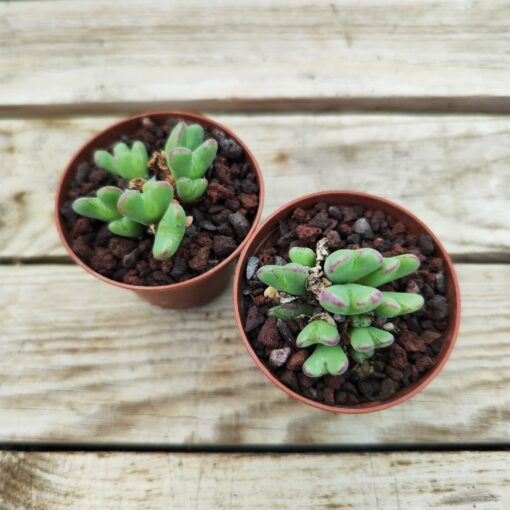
[117,180,174,225]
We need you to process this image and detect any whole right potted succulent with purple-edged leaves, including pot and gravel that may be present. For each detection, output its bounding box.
[234,191,460,413]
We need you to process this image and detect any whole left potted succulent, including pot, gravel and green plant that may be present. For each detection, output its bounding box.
[55,111,263,308]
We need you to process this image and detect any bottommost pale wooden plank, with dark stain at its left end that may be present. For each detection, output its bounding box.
[0,452,510,510]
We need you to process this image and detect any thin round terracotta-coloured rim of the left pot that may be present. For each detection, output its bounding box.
[54,110,265,293]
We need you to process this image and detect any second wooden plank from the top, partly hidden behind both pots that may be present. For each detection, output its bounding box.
[0,115,510,258]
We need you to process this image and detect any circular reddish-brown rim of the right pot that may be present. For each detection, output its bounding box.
[233,190,461,414]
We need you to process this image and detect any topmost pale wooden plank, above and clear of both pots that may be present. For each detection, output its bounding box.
[0,0,510,112]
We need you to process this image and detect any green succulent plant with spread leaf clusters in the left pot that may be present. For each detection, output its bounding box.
[73,122,221,260]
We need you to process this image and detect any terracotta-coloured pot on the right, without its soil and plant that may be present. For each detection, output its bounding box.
[234,191,460,414]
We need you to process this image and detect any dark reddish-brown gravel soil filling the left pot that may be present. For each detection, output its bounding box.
[61,118,259,286]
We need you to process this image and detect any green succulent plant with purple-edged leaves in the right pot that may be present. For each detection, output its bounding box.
[257,239,424,377]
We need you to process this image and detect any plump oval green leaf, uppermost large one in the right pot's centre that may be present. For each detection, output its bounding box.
[324,248,384,287]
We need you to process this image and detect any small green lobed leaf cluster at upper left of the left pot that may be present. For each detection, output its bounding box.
[94,141,148,180]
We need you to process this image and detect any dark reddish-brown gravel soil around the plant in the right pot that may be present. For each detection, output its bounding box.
[243,203,449,406]
